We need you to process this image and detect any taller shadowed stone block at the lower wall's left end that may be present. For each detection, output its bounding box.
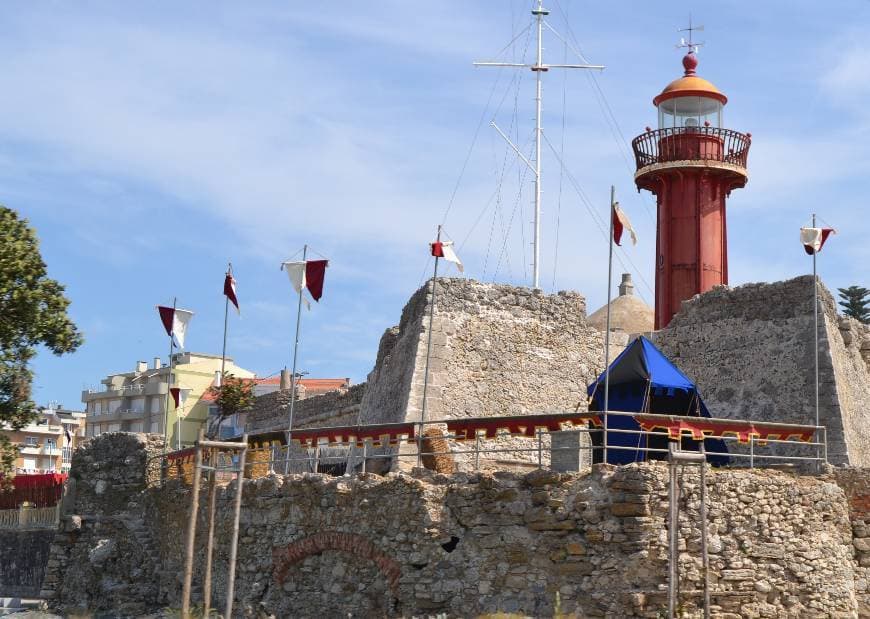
[40,432,165,616]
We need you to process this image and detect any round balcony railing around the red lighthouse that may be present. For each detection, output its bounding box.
[631,127,752,170]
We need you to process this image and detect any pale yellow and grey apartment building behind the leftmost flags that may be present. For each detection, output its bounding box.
[82,352,254,449]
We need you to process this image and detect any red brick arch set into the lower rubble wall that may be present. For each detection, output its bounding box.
[272,531,402,597]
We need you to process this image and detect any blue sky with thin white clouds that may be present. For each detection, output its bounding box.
[8,0,870,406]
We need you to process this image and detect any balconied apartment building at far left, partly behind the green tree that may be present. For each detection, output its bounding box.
[0,404,85,474]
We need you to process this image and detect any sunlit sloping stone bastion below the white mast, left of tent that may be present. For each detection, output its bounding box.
[362,278,626,423]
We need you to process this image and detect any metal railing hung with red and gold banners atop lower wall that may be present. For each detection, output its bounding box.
[150,411,827,485]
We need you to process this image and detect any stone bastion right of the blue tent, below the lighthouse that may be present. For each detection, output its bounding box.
[651,276,870,466]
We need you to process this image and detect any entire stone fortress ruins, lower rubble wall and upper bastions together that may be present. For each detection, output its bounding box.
[18,277,870,619]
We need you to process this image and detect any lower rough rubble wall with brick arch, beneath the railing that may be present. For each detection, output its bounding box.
[43,434,870,618]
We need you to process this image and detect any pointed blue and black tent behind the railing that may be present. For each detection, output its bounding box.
[587,336,728,464]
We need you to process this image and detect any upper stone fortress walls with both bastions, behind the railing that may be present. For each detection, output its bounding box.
[250,277,870,466]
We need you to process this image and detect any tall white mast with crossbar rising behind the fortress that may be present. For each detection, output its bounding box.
[474,0,604,289]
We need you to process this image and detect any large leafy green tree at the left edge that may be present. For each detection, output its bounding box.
[0,206,82,479]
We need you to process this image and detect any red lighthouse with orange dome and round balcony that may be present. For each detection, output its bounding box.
[632,49,751,329]
